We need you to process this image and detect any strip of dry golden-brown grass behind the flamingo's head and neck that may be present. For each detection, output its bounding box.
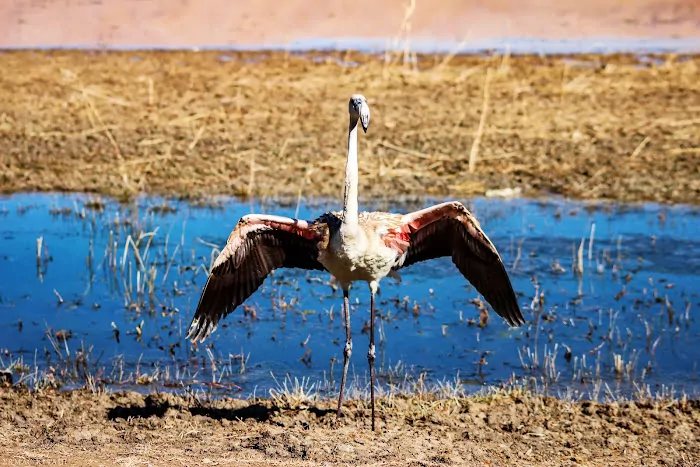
[0,51,700,203]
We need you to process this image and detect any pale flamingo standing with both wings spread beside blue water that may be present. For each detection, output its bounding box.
[187,94,525,431]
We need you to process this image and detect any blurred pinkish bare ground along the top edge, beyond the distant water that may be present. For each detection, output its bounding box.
[0,0,700,47]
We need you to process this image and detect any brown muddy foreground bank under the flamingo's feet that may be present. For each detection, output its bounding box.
[0,389,700,466]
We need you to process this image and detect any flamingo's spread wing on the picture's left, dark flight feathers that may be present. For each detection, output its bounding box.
[187,215,326,342]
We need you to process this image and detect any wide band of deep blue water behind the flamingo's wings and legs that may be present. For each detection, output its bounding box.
[0,194,700,394]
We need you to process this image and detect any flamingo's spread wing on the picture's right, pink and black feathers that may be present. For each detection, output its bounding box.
[394,201,525,326]
